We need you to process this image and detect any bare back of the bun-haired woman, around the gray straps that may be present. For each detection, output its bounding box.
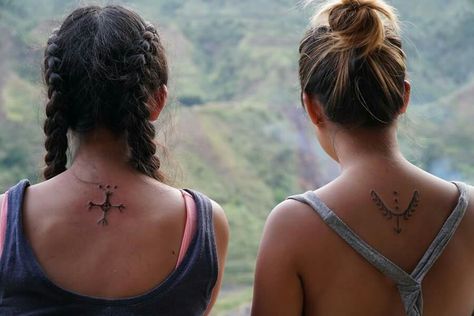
[285,170,474,316]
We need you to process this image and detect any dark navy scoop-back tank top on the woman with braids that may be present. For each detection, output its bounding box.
[0,180,218,316]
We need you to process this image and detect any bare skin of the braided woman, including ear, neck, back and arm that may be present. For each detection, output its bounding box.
[0,87,229,311]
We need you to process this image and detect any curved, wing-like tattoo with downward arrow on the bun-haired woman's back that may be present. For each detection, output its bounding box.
[370,190,420,234]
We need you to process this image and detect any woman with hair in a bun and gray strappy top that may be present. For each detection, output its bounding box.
[252,0,474,316]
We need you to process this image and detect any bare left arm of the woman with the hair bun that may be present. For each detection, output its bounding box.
[252,201,303,316]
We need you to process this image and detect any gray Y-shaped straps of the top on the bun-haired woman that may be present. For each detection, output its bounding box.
[289,182,469,316]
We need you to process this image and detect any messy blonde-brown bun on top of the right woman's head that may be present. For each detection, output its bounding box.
[313,0,398,56]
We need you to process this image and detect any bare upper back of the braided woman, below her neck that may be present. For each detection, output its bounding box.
[23,172,185,297]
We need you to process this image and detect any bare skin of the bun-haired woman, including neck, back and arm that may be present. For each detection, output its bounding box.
[252,83,474,316]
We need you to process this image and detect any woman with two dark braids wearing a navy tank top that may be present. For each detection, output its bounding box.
[0,6,228,316]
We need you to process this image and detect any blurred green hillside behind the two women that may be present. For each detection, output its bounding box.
[0,0,474,315]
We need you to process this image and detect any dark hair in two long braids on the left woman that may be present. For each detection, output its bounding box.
[44,6,168,180]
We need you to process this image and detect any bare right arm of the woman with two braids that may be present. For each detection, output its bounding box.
[206,201,229,315]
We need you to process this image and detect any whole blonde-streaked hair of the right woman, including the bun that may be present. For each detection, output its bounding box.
[299,0,406,126]
